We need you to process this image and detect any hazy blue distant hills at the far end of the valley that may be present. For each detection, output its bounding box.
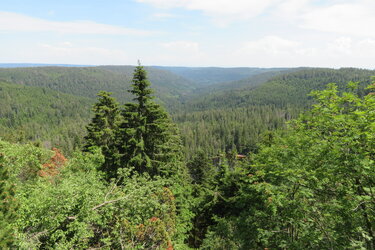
[153,66,288,87]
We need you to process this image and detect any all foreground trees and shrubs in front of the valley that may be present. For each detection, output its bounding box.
[0,66,375,249]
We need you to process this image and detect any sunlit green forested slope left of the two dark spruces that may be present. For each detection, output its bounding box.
[0,82,93,152]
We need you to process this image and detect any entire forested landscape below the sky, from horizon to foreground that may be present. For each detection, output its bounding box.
[0,65,375,249]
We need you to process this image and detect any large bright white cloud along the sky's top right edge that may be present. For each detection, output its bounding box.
[135,0,375,36]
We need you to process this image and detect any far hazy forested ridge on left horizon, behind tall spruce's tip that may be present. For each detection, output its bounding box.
[0,66,194,105]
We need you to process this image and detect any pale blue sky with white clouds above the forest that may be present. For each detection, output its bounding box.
[0,0,375,69]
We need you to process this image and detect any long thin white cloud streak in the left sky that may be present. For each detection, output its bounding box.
[0,12,153,36]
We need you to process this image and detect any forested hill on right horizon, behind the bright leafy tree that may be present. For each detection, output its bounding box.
[186,68,375,110]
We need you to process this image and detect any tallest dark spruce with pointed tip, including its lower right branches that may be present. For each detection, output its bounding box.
[118,65,192,243]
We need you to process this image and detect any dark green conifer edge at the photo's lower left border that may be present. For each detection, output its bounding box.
[0,154,18,249]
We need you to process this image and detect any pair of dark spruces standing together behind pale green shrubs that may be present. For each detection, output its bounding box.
[81,66,192,244]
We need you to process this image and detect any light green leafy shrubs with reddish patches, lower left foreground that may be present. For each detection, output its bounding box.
[0,142,190,249]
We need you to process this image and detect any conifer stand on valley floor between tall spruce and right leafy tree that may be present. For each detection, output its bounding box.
[174,105,298,158]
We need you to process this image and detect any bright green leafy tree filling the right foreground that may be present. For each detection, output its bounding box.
[205,83,375,249]
